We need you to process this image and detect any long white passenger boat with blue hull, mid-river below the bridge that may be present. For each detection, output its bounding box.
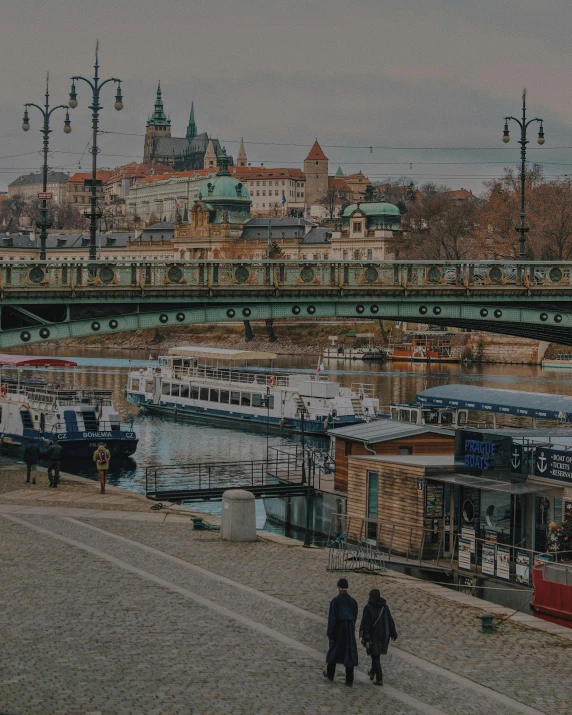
[127,345,379,434]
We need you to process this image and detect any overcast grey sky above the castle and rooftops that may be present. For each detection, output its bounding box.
[0,0,572,193]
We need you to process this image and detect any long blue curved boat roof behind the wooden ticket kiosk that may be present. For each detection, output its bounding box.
[417,385,572,422]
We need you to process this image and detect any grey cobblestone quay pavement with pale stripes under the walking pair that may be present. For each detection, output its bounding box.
[0,512,572,715]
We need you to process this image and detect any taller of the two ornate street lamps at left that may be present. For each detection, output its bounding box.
[69,42,123,261]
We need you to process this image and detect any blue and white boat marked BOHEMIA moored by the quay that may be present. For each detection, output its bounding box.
[0,356,137,460]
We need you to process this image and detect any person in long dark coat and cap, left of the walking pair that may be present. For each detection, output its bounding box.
[324,578,358,686]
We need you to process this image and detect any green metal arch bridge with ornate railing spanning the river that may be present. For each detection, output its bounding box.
[0,260,572,349]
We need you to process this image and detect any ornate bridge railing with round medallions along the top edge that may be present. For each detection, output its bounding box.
[0,259,572,291]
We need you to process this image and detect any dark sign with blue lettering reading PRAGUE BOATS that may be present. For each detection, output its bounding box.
[455,430,524,480]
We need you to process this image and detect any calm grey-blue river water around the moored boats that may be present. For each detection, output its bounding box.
[5,345,572,527]
